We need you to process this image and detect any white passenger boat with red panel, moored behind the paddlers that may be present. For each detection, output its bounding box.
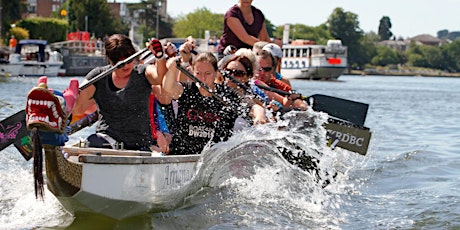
[281,40,347,80]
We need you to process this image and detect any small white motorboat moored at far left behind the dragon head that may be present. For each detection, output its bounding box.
[0,39,64,77]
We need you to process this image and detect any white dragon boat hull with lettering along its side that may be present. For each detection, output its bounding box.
[45,146,200,219]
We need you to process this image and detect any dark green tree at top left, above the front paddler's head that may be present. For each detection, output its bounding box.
[67,0,129,37]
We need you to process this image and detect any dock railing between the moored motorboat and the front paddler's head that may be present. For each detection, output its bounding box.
[50,40,105,56]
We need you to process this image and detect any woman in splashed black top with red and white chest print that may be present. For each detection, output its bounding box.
[163,52,262,154]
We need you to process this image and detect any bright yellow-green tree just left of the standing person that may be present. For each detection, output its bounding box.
[173,8,224,38]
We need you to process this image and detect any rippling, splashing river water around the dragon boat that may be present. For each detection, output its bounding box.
[0,76,460,229]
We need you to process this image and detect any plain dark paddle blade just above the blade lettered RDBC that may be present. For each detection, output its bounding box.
[307,94,369,127]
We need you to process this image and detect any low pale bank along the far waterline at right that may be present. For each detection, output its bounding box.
[344,67,460,77]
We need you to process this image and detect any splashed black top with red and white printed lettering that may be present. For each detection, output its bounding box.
[170,83,240,154]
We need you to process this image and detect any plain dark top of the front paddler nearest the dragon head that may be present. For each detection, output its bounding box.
[86,65,153,149]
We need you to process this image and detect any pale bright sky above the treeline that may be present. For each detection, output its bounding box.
[117,0,460,38]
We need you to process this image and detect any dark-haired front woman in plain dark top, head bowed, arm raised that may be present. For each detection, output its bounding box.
[73,34,166,150]
